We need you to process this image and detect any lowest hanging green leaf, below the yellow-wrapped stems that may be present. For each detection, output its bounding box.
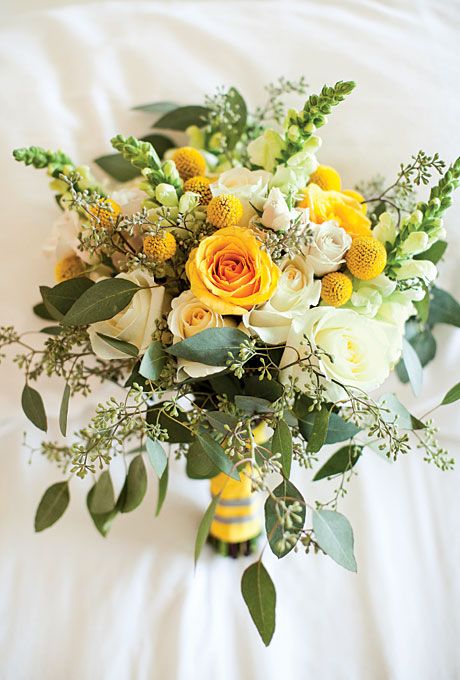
[241,560,276,647]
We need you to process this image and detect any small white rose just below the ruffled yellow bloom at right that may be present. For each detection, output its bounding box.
[307,222,351,276]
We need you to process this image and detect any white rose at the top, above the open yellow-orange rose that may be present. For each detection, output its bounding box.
[210,168,271,227]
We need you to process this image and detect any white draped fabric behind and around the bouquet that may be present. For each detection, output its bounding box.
[0,0,460,680]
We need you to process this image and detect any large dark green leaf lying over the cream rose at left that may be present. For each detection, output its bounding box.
[63,279,141,326]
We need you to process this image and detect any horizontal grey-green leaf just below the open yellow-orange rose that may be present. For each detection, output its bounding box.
[166,327,248,366]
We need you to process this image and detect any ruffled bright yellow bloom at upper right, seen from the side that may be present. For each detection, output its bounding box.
[298,183,371,237]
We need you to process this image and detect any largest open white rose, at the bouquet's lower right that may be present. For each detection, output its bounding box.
[280,307,402,400]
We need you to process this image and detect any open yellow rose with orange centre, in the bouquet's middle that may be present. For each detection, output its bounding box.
[187,227,280,314]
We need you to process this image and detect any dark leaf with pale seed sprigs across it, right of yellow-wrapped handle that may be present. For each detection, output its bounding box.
[265,479,305,558]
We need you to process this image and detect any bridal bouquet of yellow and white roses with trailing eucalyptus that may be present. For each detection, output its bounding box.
[4,79,460,644]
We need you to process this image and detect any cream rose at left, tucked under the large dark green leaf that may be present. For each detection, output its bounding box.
[88,268,165,359]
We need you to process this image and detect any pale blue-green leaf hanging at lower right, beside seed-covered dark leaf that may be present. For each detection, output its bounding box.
[313,510,357,571]
